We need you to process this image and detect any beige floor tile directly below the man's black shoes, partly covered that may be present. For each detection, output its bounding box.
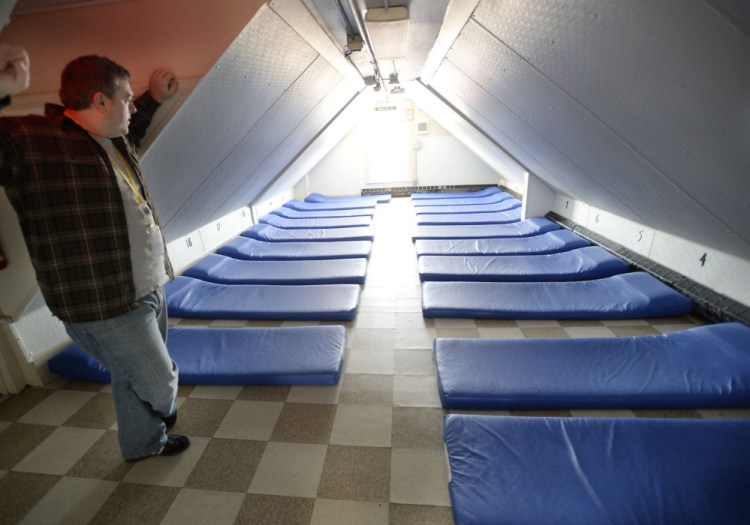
[123,437,209,487]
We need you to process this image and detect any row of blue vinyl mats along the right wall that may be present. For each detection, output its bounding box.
[413,186,750,524]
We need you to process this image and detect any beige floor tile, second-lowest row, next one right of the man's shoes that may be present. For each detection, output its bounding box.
[248,442,327,498]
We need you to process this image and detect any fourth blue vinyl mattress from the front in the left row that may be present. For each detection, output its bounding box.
[216,235,372,261]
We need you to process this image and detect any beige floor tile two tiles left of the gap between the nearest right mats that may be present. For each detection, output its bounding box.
[330,404,393,447]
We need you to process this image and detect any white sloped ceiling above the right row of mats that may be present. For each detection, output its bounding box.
[429,0,750,259]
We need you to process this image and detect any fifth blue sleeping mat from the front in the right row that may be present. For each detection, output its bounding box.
[414,230,589,257]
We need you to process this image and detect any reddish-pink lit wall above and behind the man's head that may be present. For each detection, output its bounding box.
[0,0,264,108]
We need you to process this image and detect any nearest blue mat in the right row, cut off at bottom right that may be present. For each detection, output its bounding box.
[444,414,750,525]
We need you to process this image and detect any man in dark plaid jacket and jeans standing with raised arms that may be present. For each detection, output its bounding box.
[0,46,190,461]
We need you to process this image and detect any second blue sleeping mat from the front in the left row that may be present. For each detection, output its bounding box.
[165,276,359,321]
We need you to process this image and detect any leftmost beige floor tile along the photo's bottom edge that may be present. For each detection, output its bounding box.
[20,477,117,525]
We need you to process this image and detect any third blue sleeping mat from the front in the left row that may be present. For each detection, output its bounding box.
[183,253,367,284]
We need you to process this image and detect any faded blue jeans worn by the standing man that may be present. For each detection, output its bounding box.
[63,288,177,459]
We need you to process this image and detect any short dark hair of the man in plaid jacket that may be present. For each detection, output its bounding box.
[60,55,130,111]
